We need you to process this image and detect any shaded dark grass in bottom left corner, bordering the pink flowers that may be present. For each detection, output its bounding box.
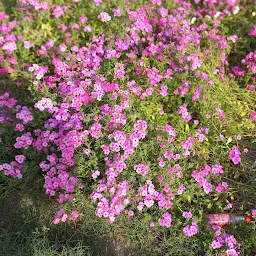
[0,170,138,256]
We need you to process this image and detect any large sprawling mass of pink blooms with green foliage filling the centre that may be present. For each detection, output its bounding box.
[0,0,256,255]
